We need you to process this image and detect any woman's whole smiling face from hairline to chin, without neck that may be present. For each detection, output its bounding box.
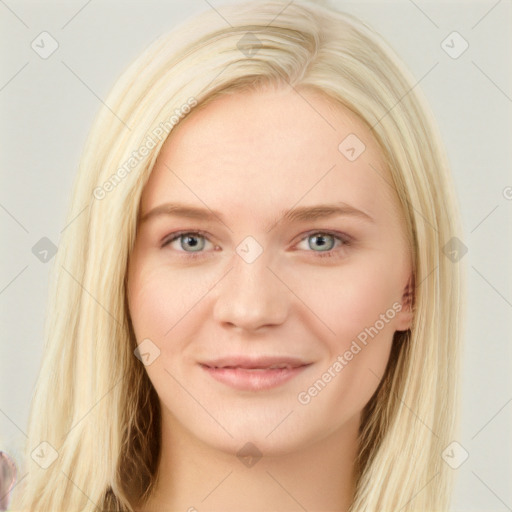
[128,88,411,454]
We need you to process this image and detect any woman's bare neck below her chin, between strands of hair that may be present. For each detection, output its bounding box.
[136,413,359,512]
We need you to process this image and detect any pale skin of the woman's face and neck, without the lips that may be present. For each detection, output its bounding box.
[128,86,412,512]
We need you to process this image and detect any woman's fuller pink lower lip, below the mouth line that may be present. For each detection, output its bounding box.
[201,365,309,391]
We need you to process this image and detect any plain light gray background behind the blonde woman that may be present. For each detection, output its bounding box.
[0,0,512,511]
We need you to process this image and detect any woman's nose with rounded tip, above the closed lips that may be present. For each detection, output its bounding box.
[214,252,290,331]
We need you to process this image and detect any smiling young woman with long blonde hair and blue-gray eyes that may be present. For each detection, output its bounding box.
[13,0,462,511]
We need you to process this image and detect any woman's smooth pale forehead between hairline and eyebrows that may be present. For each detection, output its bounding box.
[141,87,397,226]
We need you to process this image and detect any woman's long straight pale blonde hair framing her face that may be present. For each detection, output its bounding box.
[13,0,464,512]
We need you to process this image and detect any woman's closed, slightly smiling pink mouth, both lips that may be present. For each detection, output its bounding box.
[200,357,312,391]
